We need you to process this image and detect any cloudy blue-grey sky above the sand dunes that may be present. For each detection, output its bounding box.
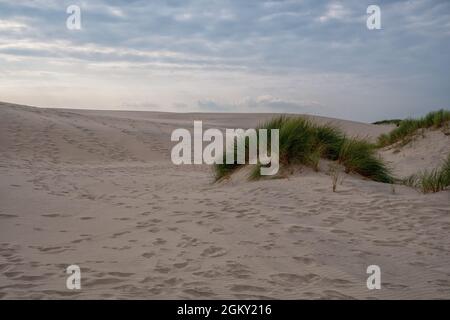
[0,0,450,122]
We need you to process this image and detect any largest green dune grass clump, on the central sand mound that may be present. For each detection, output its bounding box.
[215,116,393,183]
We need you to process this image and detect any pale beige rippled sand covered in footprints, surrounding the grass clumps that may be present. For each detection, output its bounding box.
[0,103,450,299]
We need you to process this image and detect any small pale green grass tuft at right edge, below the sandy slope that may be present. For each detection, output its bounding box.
[403,154,450,193]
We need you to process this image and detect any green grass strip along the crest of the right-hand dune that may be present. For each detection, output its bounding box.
[378,109,450,147]
